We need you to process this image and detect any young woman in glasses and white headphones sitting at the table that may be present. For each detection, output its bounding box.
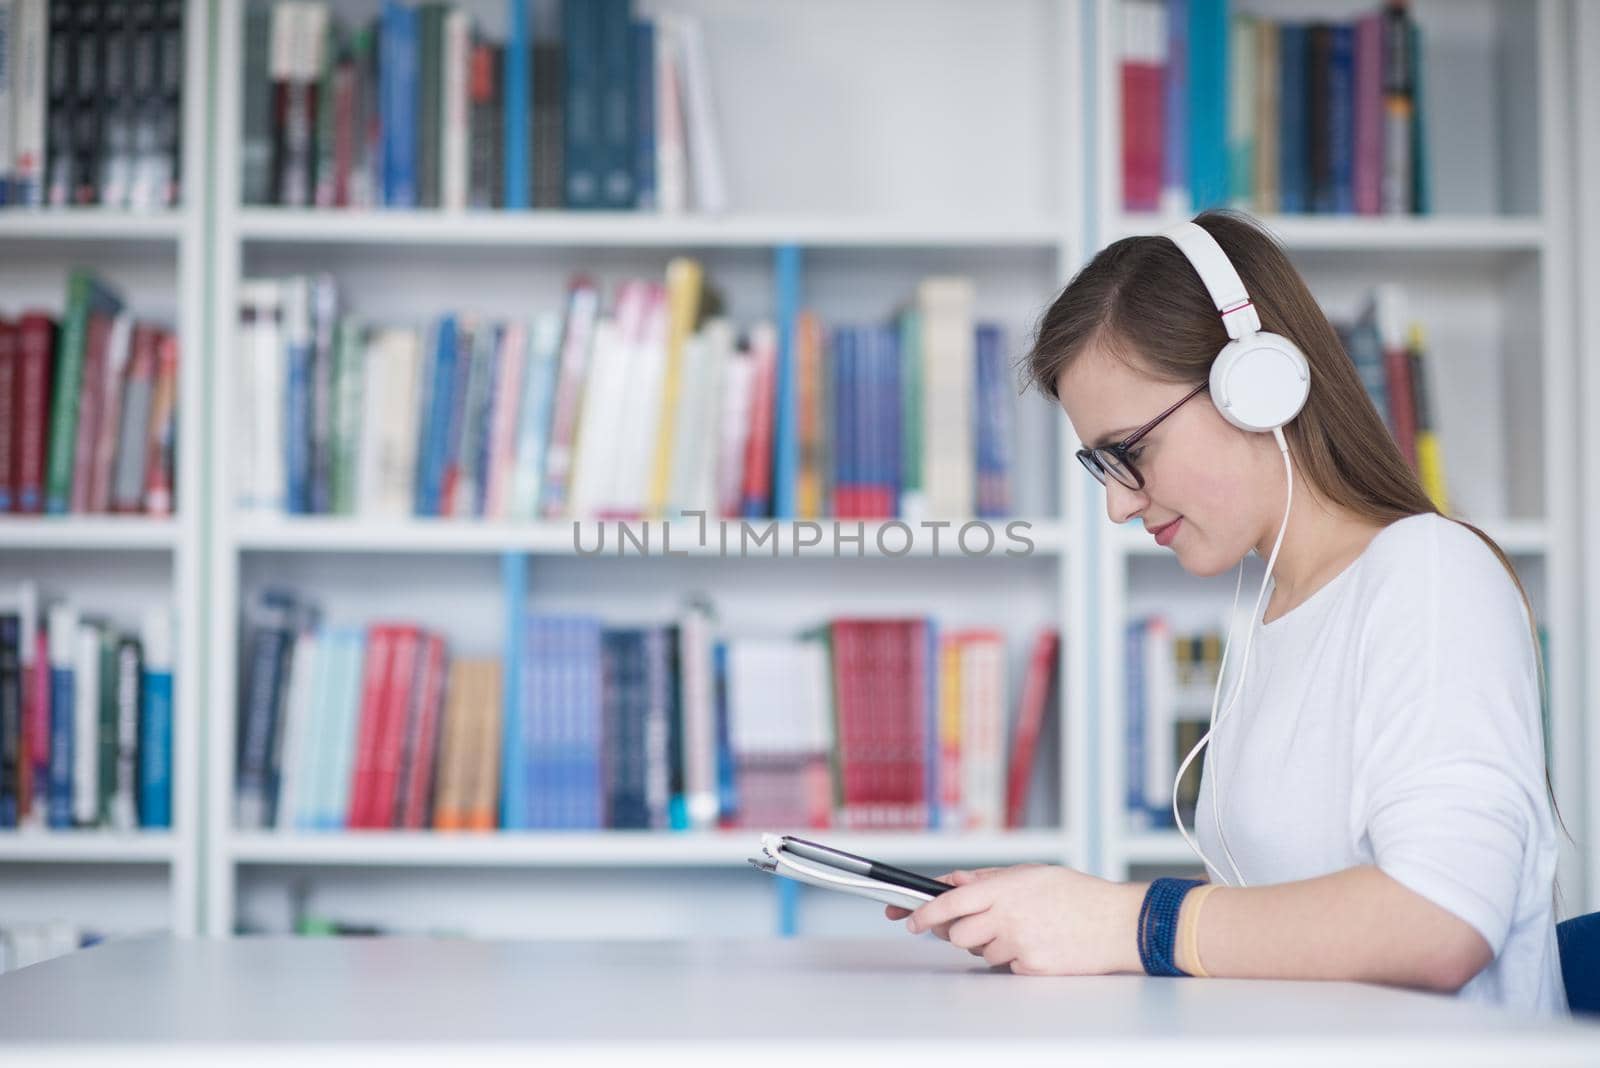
[888,213,1566,1014]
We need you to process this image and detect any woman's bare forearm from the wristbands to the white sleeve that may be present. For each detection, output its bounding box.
[1178,865,1493,993]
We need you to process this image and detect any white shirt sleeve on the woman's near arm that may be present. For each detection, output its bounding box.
[1352,524,1547,956]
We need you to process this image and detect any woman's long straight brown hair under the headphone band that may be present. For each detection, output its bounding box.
[1024,209,1571,838]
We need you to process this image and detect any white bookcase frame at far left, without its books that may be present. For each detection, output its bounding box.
[0,0,211,935]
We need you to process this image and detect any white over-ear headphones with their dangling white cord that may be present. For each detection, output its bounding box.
[1166,222,1310,886]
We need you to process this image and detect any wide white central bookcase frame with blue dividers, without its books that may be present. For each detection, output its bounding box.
[203,0,1088,937]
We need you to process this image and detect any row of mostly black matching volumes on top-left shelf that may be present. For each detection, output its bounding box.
[0,0,184,209]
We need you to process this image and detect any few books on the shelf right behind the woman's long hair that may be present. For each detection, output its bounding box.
[1334,283,1450,515]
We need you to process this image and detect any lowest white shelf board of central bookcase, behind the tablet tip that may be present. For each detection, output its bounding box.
[227,830,1070,868]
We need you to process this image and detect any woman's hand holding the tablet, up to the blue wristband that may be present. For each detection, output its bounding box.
[885,865,1144,975]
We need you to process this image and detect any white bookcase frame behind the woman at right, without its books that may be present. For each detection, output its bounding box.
[1075,0,1597,913]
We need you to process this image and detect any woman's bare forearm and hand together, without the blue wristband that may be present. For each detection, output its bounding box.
[908,865,1493,991]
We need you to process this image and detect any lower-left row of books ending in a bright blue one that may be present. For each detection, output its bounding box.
[0,582,173,830]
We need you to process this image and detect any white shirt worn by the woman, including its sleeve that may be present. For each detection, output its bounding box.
[1195,515,1568,1015]
